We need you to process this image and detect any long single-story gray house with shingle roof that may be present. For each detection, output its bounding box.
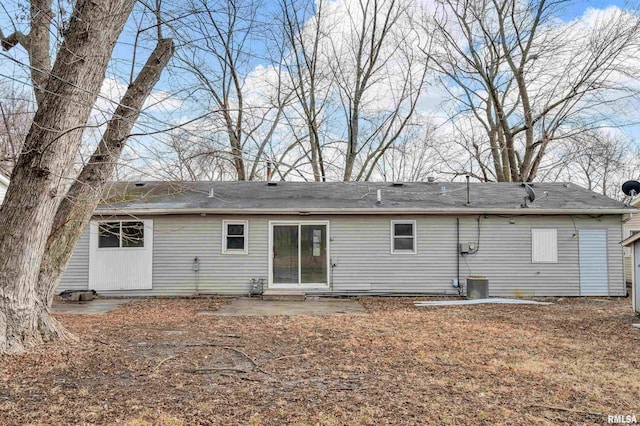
[59,182,635,296]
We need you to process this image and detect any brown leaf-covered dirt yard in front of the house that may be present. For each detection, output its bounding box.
[0,298,640,425]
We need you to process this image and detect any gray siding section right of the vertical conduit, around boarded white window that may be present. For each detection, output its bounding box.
[462,216,625,296]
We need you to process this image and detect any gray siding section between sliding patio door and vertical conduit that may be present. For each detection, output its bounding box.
[331,216,457,294]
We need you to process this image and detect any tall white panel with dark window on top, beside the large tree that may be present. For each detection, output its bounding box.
[89,219,153,291]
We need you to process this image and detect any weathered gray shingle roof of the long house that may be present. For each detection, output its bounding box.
[97,182,635,214]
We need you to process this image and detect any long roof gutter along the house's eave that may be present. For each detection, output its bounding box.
[93,208,638,216]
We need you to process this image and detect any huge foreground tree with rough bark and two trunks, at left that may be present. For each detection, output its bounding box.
[0,0,173,353]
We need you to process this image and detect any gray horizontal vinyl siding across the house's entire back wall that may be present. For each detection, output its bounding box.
[55,215,624,296]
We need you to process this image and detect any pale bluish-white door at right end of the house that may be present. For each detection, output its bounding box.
[579,229,609,296]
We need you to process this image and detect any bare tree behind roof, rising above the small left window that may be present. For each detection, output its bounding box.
[172,0,290,180]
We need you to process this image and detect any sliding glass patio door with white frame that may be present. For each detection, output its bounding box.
[271,222,329,287]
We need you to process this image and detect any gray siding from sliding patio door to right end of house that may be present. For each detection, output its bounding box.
[331,216,624,296]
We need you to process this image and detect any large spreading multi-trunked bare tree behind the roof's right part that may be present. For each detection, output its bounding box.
[424,0,640,181]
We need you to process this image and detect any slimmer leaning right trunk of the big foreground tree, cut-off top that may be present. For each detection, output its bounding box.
[37,38,174,330]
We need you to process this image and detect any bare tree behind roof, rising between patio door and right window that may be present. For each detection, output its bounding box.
[329,0,429,181]
